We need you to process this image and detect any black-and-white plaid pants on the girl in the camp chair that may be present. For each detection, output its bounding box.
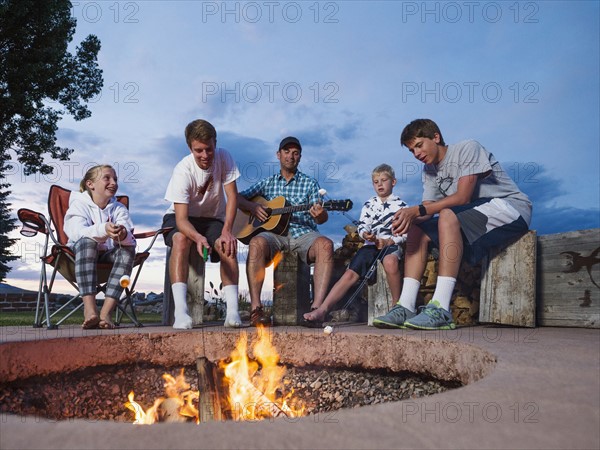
[73,238,135,300]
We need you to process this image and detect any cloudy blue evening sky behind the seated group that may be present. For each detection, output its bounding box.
[7,1,600,292]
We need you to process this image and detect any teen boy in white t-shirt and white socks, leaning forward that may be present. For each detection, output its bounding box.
[163,119,241,329]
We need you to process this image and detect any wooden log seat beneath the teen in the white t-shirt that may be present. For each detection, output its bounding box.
[162,246,204,326]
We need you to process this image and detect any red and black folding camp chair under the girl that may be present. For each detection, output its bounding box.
[17,185,170,329]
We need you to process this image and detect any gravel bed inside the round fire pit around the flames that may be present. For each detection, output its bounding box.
[0,364,460,422]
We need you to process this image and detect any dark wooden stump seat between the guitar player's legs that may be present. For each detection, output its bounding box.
[273,252,310,325]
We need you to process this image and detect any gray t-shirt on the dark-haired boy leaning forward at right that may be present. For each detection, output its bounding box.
[423,140,531,226]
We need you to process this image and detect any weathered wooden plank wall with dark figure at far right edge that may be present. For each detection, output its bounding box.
[538,228,600,328]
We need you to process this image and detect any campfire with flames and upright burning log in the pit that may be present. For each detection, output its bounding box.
[125,328,305,424]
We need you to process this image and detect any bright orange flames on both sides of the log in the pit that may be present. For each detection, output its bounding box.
[125,327,305,425]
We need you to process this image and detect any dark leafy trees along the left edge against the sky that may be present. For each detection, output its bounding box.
[0,0,103,281]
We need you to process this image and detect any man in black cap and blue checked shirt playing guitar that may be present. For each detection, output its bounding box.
[238,136,333,326]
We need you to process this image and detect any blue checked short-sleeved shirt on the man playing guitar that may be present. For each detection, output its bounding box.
[240,171,320,238]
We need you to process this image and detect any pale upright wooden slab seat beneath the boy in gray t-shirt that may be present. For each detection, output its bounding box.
[479,231,536,327]
